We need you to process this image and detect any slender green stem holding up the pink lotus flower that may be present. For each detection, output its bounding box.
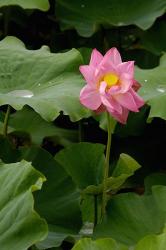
[101,112,111,219]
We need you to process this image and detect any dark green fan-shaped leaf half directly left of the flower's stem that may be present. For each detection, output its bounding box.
[55,142,105,189]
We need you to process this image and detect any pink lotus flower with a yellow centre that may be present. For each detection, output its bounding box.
[80,48,144,124]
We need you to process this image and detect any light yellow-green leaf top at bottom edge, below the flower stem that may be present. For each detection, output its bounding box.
[72,238,128,250]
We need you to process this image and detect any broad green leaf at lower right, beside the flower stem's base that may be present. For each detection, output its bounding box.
[95,186,166,246]
